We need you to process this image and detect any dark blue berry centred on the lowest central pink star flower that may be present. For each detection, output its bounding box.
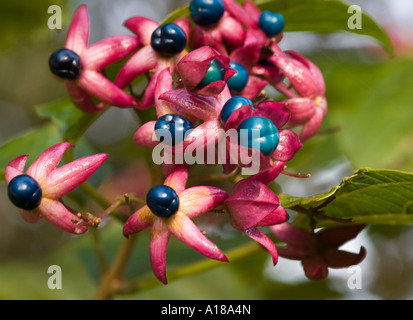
[146,185,179,218]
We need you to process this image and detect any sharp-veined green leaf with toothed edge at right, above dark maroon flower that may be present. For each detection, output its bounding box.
[280,168,413,225]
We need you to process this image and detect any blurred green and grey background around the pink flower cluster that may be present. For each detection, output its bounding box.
[0,0,413,300]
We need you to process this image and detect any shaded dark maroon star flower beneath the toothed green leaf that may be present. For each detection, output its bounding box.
[270,223,366,280]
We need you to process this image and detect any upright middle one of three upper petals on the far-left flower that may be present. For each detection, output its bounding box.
[27,142,73,182]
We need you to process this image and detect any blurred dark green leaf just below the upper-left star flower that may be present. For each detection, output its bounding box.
[35,99,102,143]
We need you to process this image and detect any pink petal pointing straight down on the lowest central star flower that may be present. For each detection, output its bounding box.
[149,219,171,284]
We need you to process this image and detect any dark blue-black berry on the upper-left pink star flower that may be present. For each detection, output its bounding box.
[49,49,81,80]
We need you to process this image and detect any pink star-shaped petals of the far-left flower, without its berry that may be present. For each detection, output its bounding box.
[5,142,107,234]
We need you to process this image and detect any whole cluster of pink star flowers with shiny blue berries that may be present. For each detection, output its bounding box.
[6,0,363,283]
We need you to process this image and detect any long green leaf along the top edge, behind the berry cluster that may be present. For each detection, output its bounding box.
[163,0,393,53]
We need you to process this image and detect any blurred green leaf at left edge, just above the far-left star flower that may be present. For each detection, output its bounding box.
[0,124,61,179]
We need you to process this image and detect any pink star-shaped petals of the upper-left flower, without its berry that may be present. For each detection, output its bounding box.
[53,5,138,112]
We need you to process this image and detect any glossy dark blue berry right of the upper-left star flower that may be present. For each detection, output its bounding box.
[151,23,187,57]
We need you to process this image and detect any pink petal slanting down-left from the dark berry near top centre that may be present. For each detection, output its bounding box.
[115,46,158,88]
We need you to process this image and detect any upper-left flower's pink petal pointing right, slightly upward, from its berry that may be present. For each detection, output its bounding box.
[82,35,139,71]
